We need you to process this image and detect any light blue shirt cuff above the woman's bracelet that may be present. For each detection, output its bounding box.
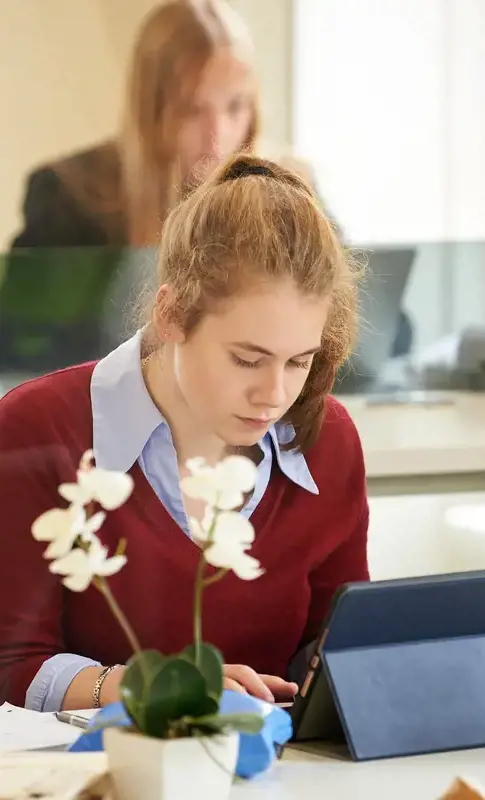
[25,653,101,711]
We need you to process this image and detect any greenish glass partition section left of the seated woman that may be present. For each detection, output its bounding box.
[0,247,155,391]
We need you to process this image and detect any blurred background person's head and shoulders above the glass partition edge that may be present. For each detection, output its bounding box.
[12,0,322,248]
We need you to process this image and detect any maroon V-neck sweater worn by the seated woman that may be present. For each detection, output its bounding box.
[0,364,368,705]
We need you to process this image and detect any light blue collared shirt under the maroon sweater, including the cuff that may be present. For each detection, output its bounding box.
[25,331,318,711]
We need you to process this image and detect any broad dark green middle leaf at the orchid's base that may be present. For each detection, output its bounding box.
[142,657,219,738]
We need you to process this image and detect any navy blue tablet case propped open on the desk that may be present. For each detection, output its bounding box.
[292,572,485,761]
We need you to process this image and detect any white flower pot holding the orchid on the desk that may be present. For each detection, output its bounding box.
[103,728,239,800]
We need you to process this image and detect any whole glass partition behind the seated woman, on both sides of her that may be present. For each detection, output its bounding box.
[0,242,485,396]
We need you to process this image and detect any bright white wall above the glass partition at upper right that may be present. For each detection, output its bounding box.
[294,0,485,242]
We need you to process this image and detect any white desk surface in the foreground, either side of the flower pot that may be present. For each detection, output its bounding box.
[0,748,485,800]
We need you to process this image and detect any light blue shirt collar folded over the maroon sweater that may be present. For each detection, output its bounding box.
[91,331,318,494]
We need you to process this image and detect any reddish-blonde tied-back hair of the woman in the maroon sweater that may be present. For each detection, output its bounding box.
[146,155,360,451]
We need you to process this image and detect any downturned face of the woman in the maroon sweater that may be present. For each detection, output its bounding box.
[165,280,329,446]
